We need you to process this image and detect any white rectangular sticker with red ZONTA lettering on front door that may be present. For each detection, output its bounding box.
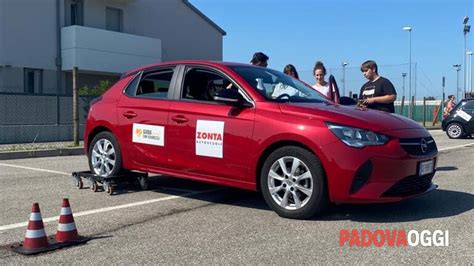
[196,120,224,158]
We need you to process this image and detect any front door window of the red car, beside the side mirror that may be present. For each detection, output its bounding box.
[181,68,236,102]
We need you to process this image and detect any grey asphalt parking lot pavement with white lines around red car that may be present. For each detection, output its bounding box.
[0,130,474,264]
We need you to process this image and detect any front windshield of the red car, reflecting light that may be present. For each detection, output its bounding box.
[230,66,328,103]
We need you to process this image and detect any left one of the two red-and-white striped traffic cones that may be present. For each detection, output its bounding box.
[22,203,49,251]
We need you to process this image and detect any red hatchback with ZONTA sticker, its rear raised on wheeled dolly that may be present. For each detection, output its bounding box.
[84,61,438,218]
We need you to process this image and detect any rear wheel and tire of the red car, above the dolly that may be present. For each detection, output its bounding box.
[88,131,123,177]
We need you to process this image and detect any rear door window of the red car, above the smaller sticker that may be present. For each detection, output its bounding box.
[135,69,174,99]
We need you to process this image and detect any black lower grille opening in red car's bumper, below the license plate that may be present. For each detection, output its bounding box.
[382,173,434,197]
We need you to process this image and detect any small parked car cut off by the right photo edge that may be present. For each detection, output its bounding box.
[441,98,474,139]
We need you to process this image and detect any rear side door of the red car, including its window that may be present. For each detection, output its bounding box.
[117,66,176,167]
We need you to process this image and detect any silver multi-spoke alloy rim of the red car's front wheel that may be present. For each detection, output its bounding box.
[268,156,313,210]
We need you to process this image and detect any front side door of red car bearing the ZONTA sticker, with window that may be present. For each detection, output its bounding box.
[167,66,255,181]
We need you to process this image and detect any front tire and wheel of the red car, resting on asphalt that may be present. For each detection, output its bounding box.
[260,146,328,219]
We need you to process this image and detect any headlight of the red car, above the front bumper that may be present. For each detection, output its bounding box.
[327,123,389,148]
